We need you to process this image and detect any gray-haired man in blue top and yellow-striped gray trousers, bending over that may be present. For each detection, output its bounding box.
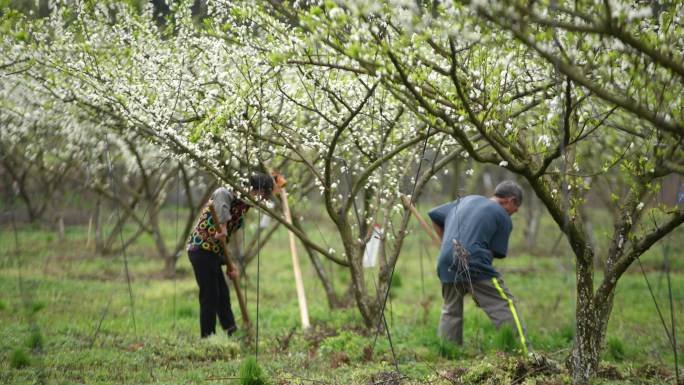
[428,181,527,353]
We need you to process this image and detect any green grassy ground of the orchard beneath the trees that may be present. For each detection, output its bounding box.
[0,207,684,384]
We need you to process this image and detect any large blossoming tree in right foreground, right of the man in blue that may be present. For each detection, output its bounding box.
[254,1,684,384]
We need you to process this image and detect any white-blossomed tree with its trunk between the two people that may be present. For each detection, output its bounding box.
[0,3,468,327]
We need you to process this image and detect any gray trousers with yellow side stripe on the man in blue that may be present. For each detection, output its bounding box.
[439,278,527,353]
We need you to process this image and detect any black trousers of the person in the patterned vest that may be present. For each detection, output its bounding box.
[188,250,237,337]
